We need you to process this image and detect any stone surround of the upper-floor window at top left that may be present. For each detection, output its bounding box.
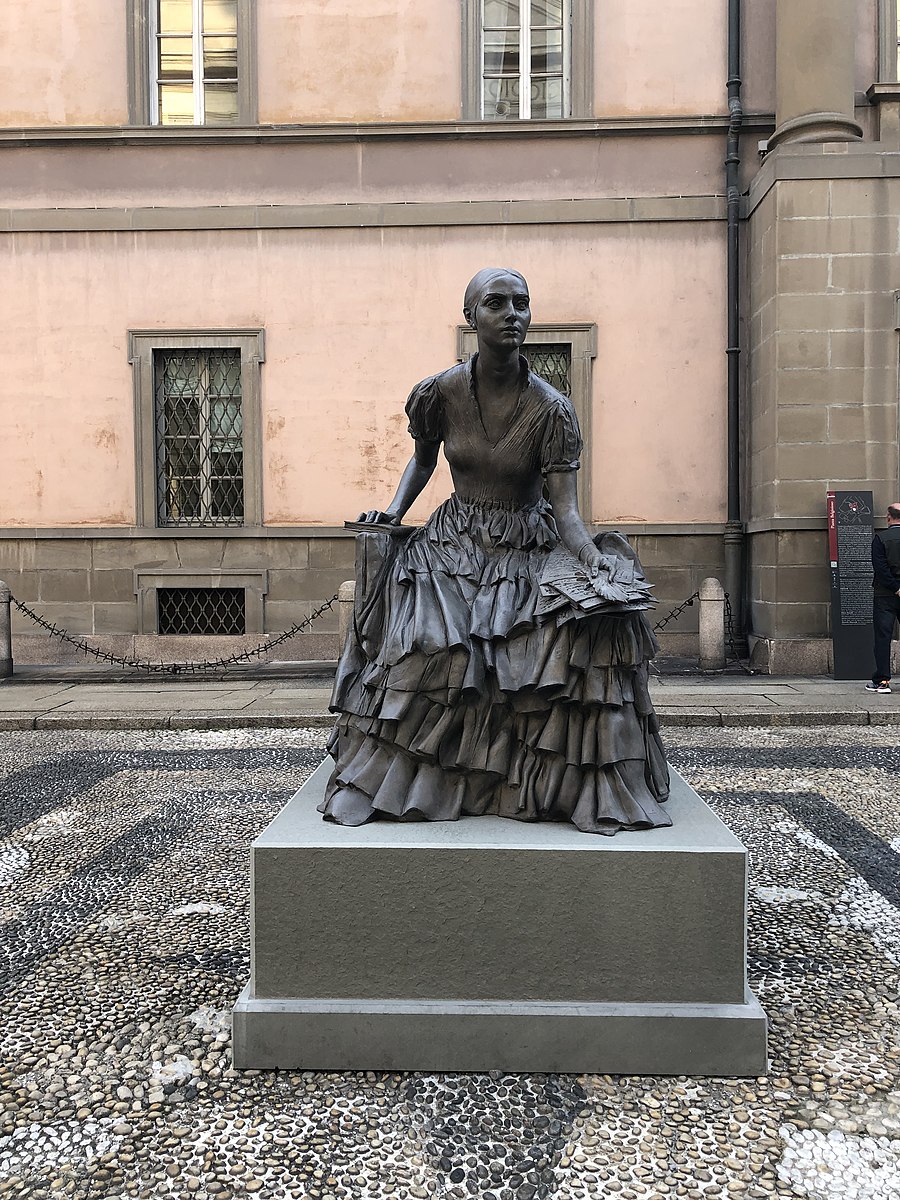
[126,0,259,124]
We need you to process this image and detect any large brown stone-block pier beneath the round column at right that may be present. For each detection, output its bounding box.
[746,143,900,672]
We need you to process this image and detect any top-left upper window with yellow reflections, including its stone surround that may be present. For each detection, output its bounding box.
[128,0,256,126]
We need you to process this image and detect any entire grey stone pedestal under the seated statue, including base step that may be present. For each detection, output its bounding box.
[234,762,766,1075]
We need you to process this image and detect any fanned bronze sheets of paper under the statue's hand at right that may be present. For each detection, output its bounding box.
[535,534,656,616]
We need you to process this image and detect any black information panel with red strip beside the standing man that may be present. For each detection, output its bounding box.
[828,492,874,679]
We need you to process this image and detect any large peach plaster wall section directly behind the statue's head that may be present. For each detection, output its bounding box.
[0,223,725,527]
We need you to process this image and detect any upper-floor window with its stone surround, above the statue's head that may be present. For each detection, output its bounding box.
[463,0,593,121]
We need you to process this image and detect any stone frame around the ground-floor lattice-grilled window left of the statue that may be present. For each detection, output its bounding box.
[128,329,265,532]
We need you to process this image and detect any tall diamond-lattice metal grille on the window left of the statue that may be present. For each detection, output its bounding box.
[154,350,244,526]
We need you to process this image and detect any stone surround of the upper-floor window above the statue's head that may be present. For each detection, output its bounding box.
[462,0,594,125]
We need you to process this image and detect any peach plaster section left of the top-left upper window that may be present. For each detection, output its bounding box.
[0,0,128,126]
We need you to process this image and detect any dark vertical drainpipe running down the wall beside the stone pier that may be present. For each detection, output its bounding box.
[725,0,744,638]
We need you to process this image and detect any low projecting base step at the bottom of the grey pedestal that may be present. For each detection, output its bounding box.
[233,985,767,1075]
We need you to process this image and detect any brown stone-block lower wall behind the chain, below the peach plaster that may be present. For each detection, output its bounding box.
[0,526,722,664]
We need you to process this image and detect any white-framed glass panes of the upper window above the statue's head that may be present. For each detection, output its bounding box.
[481,0,570,121]
